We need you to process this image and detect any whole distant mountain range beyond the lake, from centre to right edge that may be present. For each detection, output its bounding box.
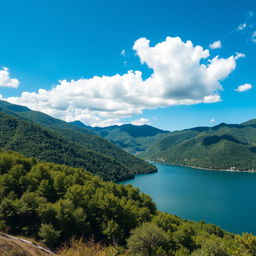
[70,119,256,171]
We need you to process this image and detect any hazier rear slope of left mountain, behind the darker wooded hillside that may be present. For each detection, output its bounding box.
[0,101,156,176]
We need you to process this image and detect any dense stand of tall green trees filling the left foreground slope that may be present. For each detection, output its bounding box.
[0,152,156,247]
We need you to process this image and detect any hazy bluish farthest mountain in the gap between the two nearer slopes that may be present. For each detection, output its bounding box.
[72,121,169,154]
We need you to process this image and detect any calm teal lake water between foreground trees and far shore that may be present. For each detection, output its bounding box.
[119,164,256,234]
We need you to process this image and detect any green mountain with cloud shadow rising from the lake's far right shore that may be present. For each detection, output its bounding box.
[140,120,256,171]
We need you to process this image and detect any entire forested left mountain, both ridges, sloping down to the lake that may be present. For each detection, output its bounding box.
[0,101,156,180]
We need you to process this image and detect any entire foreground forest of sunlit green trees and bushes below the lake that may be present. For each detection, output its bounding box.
[0,151,256,256]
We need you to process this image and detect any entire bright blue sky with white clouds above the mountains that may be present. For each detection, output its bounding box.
[0,0,256,130]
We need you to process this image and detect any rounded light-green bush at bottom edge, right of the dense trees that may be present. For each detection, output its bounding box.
[127,223,168,256]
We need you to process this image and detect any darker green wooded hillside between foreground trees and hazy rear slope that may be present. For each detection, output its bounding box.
[0,113,134,180]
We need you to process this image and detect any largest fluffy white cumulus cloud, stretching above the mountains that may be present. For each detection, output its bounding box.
[6,37,241,126]
